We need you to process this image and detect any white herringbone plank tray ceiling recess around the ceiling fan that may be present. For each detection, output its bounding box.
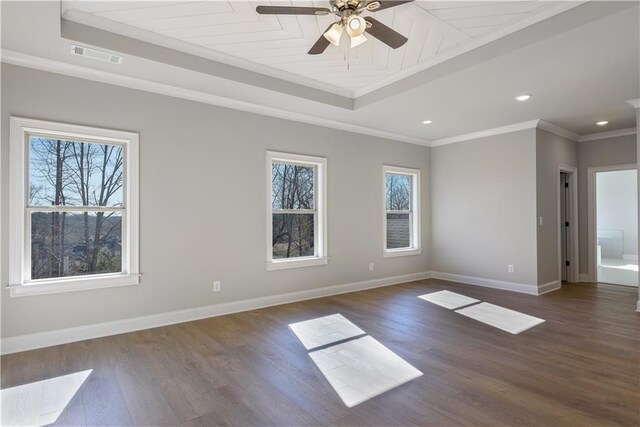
[62,0,580,97]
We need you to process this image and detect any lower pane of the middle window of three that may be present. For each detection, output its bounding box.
[272,214,315,259]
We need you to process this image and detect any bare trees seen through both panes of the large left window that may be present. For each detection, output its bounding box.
[28,136,125,280]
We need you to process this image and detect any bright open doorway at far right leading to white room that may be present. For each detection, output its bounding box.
[590,165,638,286]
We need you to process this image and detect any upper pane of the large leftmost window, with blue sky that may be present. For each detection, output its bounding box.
[29,136,124,206]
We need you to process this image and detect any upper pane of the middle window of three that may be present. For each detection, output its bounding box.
[271,163,314,209]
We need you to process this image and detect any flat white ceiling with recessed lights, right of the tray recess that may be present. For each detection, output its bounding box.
[356,4,640,140]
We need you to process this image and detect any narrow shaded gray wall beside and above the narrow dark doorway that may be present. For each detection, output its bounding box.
[536,129,578,285]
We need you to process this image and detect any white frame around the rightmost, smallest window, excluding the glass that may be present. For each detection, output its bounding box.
[382,165,422,258]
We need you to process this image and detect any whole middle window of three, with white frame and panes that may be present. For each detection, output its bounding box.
[267,152,327,270]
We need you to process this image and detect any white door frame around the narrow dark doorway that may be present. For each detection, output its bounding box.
[556,165,580,286]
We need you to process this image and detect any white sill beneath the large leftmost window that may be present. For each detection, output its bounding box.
[9,274,140,297]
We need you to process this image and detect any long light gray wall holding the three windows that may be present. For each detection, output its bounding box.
[1,64,430,337]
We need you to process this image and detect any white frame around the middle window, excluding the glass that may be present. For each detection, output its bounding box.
[266,151,329,270]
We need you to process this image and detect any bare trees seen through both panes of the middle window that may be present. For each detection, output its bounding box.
[271,162,317,259]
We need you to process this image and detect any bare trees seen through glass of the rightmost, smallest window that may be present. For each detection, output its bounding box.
[386,173,412,249]
